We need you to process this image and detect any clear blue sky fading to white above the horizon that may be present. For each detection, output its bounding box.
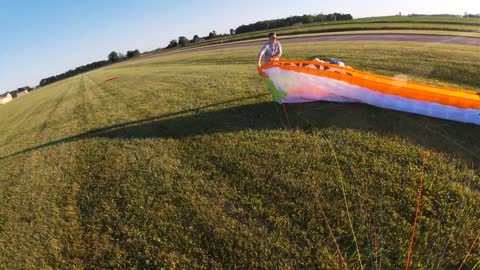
[0,0,480,93]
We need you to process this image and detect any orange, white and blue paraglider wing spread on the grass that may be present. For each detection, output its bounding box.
[258,60,480,125]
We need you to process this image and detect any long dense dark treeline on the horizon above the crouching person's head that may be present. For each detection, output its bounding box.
[235,13,353,34]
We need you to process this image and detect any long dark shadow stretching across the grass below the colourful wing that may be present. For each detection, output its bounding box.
[0,94,480,163]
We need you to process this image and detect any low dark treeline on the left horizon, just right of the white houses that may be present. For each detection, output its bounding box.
[39,50,140,86]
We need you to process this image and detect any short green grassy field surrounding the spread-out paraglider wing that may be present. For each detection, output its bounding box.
[0,42,480,269]
